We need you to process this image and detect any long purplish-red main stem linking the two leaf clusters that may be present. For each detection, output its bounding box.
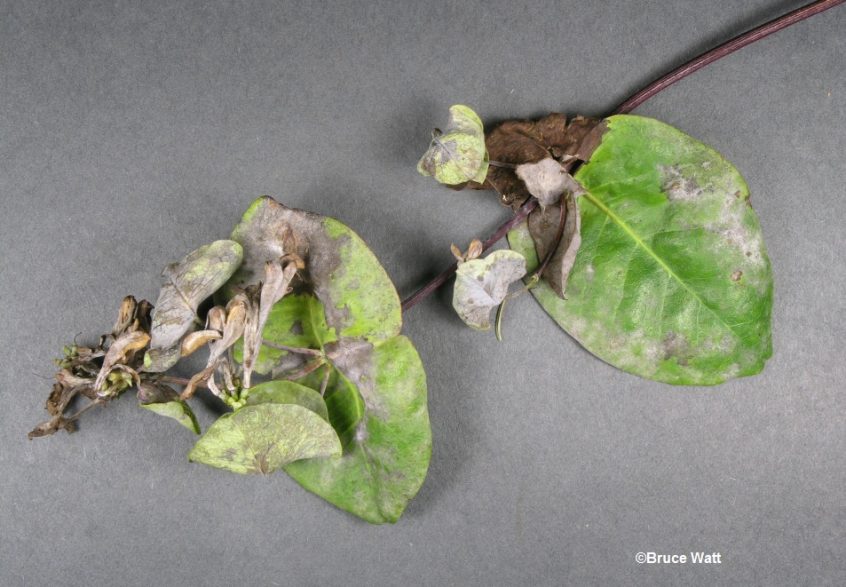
[402,0,846,312]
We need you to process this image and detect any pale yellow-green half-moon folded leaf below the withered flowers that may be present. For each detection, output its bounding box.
[188,403,341,474]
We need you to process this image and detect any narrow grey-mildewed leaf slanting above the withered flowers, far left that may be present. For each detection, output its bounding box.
[144,240,242,372]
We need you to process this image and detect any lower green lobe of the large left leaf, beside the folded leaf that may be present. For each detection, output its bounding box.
[285,336,431,524]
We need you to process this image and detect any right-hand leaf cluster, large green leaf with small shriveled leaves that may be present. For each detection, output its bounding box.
[418,105,772,385]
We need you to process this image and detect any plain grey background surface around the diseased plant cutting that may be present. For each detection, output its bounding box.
[0,0,846,586]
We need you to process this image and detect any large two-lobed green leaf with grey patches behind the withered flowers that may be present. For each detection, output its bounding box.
[229,198,431,523]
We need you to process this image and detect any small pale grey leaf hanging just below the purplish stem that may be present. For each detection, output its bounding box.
[452,250,526,330]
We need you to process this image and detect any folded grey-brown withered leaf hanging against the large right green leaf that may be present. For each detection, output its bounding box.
[528,191,582,298]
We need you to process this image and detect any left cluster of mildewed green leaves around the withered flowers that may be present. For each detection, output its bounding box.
[139,197,431,523]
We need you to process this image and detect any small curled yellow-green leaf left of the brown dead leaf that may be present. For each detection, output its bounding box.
[417,104,488,185]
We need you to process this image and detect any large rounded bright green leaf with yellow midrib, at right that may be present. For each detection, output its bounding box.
[509,116,773,385]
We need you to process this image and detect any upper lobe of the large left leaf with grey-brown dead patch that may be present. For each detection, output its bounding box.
[227,196,402,340]
